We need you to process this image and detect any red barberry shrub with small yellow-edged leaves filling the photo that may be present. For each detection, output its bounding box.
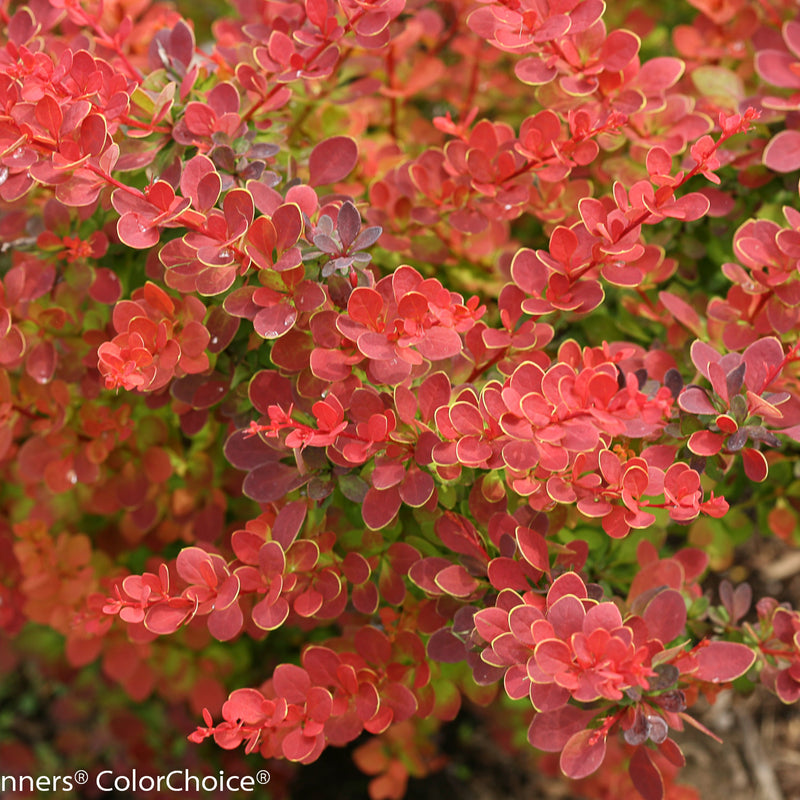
[0,0,800,800]
